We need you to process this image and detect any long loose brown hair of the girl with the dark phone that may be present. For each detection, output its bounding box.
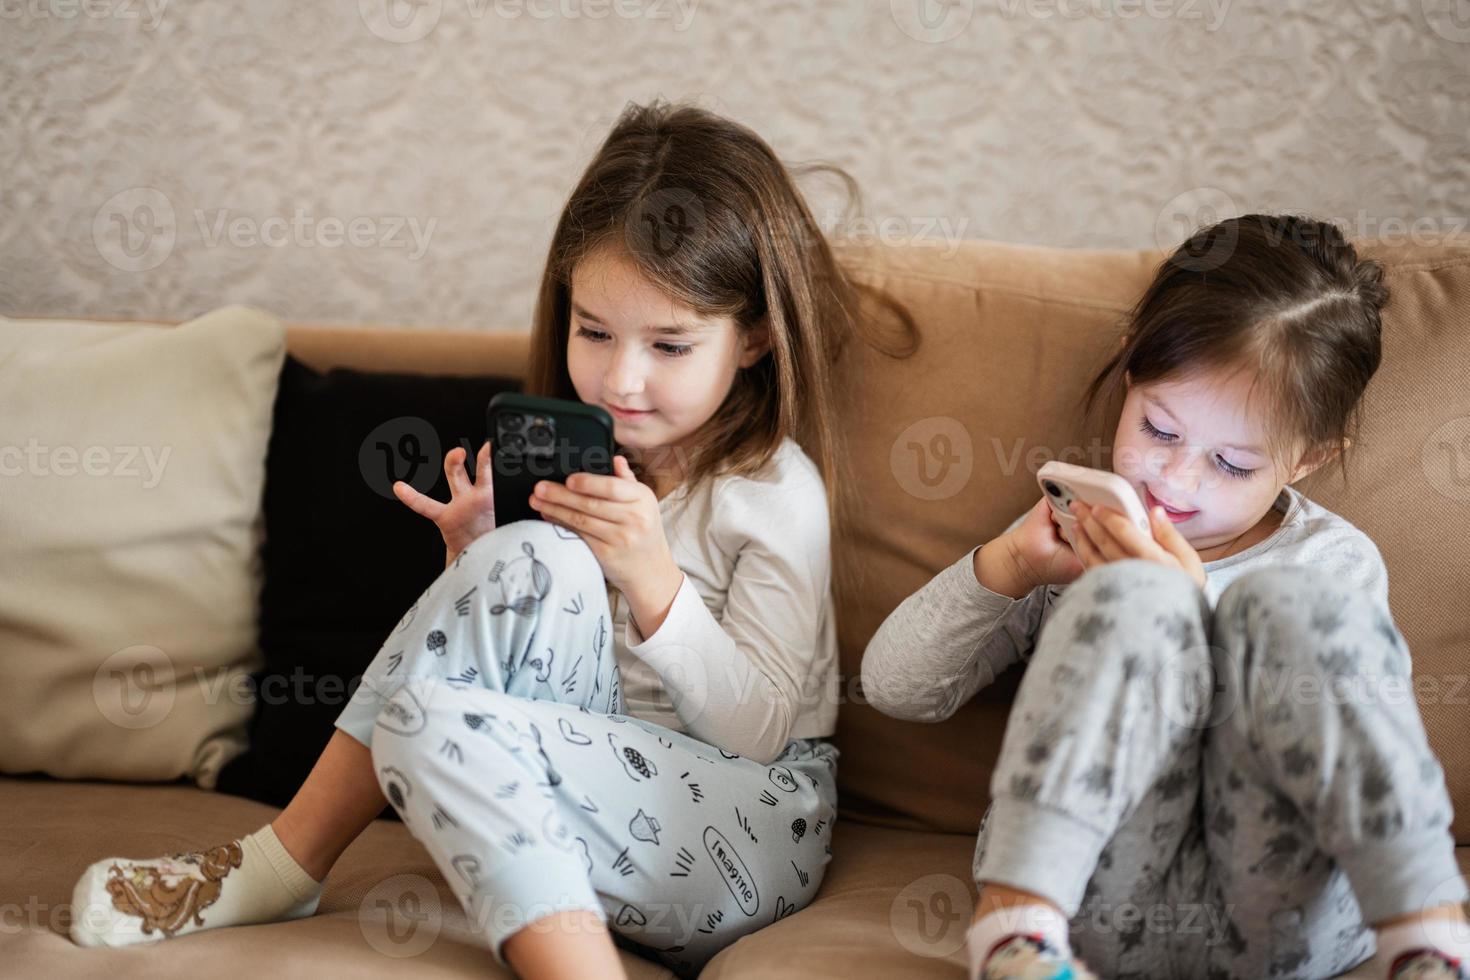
[528,101,917,537]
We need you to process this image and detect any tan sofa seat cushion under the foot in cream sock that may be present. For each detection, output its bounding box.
[0,777,673,980]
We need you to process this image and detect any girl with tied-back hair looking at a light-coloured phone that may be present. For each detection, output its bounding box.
[863,215,1470,980]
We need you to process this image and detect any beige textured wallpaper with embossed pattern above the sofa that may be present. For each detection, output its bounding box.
[0,0,1470,329]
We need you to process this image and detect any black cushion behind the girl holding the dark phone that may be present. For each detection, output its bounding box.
[219,356,520,820]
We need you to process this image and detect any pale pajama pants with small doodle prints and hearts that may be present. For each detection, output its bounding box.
[337,520,838,976]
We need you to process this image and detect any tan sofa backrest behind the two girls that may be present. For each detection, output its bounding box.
[287,238,1470,843]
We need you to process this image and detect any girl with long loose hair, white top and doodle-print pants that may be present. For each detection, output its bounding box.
[72,104,905,977]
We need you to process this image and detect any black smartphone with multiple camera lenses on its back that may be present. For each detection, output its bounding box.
[485,392,614,527]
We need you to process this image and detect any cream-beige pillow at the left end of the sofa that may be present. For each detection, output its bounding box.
[0,307,285,786]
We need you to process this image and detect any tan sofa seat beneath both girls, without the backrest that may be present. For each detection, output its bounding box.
[0,777,1470,980]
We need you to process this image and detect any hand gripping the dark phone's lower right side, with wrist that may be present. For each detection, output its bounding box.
[531,455,684,639]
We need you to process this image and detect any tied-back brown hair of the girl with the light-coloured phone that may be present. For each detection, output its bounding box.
[1083,215,1388,479]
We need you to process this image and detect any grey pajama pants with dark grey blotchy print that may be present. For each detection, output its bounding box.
[975,560,1467,980]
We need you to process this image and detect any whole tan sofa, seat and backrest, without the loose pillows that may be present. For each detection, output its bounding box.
[0,233,1470,980]
